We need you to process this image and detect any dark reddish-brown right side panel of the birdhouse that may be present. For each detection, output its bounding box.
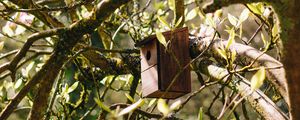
[158,28,191,93]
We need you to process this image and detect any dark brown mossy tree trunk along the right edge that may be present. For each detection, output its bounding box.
[273,0,300,120]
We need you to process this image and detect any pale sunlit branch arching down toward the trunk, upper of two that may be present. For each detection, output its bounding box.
[199,38,289,104]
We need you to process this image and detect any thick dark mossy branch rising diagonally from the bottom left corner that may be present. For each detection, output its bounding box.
[0,0,130,120]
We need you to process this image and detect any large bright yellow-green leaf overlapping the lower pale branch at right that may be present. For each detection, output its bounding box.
[251,67,266,91]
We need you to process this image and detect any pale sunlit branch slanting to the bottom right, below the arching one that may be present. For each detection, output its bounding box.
[204,65,288,120]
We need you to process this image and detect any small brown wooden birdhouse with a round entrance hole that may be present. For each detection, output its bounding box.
[136,27,191,99]
